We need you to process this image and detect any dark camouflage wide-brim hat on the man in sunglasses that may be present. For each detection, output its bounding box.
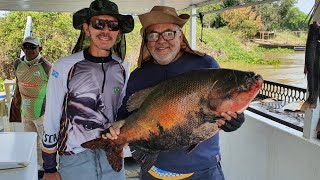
[73,0,134,33]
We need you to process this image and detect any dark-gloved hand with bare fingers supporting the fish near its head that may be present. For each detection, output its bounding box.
[217,111,244,132]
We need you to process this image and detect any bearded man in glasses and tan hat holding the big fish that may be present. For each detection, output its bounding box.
[103,6,244,180]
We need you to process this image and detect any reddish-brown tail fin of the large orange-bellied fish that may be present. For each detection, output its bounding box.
[81,138,123,172]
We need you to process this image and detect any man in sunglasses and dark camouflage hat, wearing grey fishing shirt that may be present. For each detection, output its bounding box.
[42,0,134,180]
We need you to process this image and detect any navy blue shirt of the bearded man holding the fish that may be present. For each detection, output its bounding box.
[117,52,220,179]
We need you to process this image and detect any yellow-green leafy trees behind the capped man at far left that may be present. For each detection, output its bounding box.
[0,12,79,78]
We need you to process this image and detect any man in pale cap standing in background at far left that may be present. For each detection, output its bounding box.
[9,34,51,177]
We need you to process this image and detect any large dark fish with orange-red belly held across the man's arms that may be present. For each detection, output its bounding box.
[82,69,263,171]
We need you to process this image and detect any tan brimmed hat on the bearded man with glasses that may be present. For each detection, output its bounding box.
[138,6,190,33]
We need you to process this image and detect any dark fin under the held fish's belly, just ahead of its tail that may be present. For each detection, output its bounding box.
[130,146,159,171]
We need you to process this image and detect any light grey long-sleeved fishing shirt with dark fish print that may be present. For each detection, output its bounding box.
[42,49,127,172]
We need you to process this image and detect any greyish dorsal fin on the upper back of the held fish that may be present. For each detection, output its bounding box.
[127,86,157,112]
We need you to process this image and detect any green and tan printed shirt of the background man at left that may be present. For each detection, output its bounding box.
[9,54,51,122]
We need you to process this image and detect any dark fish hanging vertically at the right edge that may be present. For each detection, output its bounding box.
[301,21,320,110]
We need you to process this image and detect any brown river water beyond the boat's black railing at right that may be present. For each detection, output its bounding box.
[219,51,307,88]
